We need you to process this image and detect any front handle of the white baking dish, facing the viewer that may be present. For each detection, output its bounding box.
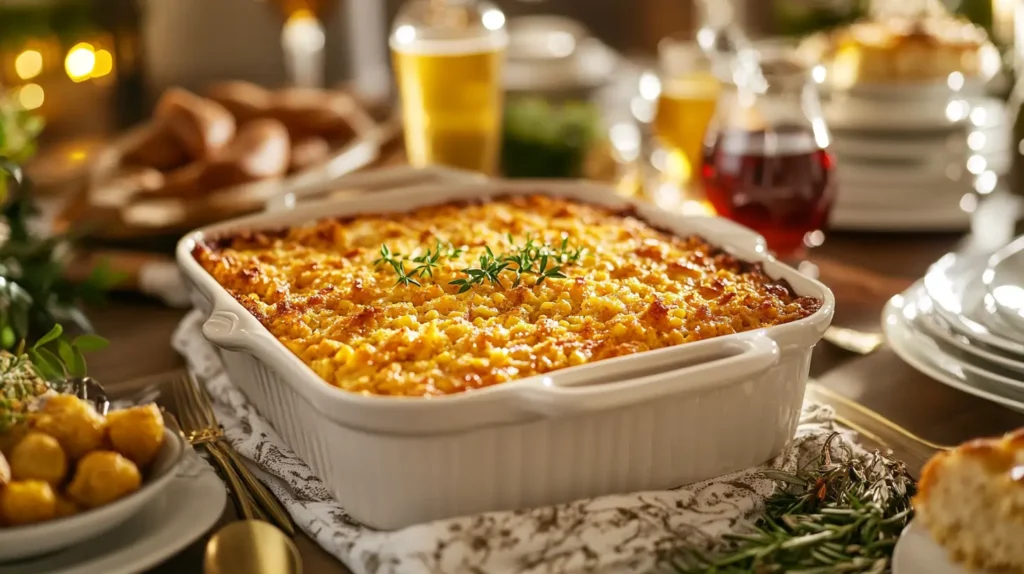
[509,329,779,416]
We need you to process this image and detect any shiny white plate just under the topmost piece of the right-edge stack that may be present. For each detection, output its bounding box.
[925,253,1024,357]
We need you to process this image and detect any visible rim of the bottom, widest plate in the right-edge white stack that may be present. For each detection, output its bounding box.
[882,284,1024,412]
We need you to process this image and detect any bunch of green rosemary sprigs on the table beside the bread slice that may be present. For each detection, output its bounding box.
[666,434,915,574]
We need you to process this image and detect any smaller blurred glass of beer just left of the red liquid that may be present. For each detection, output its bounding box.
[653,38,720,185]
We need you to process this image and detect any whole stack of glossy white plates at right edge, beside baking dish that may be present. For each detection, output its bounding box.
[883,237,1024,412]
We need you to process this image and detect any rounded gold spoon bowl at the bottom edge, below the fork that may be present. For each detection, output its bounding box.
[203,520,302,574]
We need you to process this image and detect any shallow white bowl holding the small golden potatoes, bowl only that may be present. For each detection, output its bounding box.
[0,429,185,560]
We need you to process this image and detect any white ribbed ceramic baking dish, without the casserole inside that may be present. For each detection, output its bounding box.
[177,181,835,529]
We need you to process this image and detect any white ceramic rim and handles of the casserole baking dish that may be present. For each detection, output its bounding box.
[177,180,836,435]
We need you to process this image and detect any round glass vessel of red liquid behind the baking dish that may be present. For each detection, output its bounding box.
[700,53,836,260]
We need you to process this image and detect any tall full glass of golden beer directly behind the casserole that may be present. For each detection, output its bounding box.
[390,0,508,175]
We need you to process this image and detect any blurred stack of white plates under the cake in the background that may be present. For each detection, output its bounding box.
[824,94,1011,231]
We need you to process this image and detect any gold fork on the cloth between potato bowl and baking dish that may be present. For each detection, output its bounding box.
[173,377,295,536]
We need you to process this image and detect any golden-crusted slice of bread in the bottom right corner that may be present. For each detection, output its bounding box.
[913,429,1024,573]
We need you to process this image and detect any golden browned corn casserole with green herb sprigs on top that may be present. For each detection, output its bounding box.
[194,195,821,396]
